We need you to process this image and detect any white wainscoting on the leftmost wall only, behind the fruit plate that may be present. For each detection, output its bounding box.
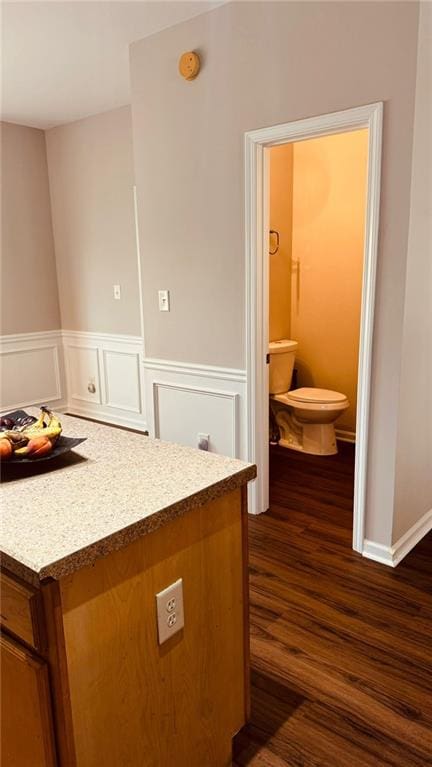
[0,330,66,412]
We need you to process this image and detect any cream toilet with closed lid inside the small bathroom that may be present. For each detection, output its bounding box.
[269,339,349,455]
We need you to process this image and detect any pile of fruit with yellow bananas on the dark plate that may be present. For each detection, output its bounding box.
[0,407,62,460]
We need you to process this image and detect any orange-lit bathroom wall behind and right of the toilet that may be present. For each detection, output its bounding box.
[291,130,368,431]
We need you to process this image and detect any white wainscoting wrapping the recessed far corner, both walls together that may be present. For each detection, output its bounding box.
[0,330,147,431]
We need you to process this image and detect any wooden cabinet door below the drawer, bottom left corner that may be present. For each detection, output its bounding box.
[0,634,56,767]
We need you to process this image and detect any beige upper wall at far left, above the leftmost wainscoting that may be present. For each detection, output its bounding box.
[1,123,60,335]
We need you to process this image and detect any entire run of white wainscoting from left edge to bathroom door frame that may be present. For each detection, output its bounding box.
[0,330,246,452]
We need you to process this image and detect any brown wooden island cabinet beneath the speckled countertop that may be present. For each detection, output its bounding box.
[1,488,249,767]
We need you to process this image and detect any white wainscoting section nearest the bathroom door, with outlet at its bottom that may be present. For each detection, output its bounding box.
[144,358,247,459]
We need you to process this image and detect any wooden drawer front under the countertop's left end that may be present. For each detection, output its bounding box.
[0,571,45,650]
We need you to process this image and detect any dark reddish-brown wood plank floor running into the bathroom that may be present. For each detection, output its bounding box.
[233,443,432,767]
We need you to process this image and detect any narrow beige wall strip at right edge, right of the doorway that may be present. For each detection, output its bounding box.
[393,3,432,543]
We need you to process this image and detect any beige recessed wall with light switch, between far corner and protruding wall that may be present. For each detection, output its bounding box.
[46,107,140,335]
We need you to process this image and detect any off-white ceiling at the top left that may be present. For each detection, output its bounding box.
[1,0,221,129]
